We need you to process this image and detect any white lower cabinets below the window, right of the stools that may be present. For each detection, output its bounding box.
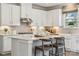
[65,36,79,52]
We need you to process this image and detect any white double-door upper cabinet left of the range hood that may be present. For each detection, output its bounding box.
[0,4,20,26]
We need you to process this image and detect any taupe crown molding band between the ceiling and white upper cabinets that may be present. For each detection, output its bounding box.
[32,3,79,11]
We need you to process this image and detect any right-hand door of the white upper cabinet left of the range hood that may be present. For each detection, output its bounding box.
[11,5,20,26]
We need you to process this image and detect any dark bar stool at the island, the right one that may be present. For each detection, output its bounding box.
[49,37,65,56]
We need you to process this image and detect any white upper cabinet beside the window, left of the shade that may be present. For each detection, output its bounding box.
[48,9,62,26]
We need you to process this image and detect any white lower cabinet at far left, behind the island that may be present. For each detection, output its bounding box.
[0,36,11,54]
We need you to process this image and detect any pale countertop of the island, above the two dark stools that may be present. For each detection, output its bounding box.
[9,34,70,40]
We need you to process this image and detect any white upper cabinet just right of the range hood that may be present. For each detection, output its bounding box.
[32,9,49,26]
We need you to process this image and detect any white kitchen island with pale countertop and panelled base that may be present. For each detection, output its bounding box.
[11,34,67,56]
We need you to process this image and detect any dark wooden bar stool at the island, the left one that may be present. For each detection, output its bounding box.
[34,38,53,56]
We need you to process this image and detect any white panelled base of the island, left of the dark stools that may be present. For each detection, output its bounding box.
[12,39,32,56]
